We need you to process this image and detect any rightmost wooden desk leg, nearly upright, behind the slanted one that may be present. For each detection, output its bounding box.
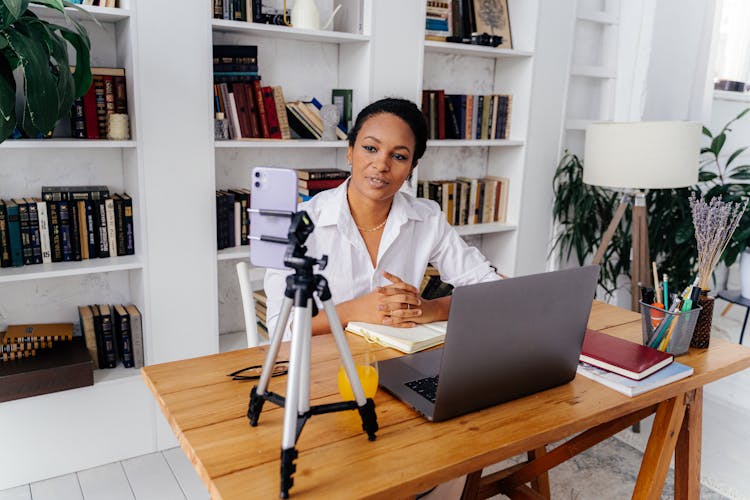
[674,387,703,499]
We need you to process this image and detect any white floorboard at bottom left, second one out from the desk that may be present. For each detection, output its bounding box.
[121,452,185,500]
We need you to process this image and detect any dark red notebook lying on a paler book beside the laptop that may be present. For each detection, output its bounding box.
[580,329,674,380]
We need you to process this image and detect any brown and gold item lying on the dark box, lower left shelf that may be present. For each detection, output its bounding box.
[0,323,73,362]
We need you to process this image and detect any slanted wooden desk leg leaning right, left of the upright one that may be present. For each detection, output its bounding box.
[633,394,687,499]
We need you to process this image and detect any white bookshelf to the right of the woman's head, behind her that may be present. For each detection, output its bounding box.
[419,0,539,275]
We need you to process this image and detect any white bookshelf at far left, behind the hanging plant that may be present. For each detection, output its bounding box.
[0,0,156,490]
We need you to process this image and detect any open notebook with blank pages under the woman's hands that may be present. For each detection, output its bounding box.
[346,321,448,354]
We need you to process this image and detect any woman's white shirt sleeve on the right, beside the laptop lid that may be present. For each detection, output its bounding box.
[430,213,501,286]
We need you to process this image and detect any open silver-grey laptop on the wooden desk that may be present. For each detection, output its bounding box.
[378,266,599,422]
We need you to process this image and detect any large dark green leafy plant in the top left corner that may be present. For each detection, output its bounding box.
[0,0,91,142]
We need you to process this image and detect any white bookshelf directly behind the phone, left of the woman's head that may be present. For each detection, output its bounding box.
[212,0,375,337]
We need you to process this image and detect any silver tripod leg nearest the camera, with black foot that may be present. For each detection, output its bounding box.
[281,306,310,498]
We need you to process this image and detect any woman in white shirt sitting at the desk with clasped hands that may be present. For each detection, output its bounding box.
[264,98,500,338]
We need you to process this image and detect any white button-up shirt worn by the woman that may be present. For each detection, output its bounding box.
[264,181,500,339]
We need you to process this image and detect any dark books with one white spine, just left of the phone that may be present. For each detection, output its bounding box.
[216,188,250,250]
